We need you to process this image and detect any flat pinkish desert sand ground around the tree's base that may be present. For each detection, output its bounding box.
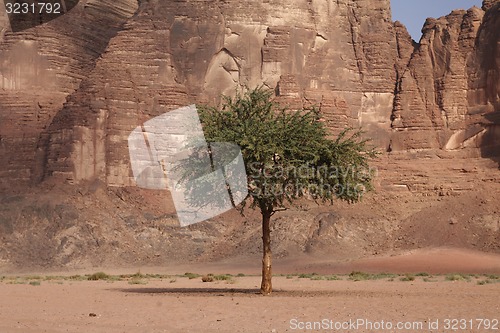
[0,249,500,333]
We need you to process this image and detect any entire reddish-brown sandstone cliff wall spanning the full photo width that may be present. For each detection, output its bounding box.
[0,0,500,186]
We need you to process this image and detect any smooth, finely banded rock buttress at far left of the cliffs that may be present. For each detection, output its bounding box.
[0,0,137,187]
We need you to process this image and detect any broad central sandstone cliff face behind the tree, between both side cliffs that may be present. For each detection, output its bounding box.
[41,1,402,185]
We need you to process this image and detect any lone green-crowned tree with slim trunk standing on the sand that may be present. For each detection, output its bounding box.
[195,87,376,295]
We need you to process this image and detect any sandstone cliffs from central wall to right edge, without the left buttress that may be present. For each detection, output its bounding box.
[37,0,500,186]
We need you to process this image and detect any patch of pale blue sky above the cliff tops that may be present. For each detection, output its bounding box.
[391,0,483,42]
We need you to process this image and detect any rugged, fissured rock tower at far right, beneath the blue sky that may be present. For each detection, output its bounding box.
[391,1,500,154]
